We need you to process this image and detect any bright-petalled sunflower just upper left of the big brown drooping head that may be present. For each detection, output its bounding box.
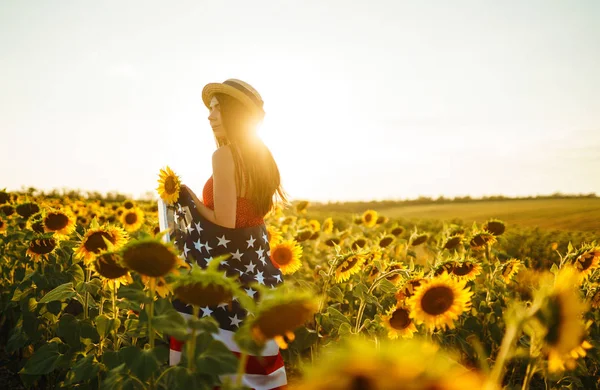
[74,219,128,265]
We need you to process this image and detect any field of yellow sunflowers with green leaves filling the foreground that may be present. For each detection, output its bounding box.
[0,184,600,389]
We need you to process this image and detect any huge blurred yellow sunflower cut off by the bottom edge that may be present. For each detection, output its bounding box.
[290,337,498,390]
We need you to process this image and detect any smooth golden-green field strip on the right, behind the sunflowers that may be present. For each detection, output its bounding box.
[314,199,600,234]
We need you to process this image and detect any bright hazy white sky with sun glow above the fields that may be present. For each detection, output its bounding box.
[0,0,600,202]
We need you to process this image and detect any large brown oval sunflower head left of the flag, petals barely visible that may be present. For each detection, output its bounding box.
[122,238,186,278]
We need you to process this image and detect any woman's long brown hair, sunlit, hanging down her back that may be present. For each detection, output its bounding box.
[215,94,288,215]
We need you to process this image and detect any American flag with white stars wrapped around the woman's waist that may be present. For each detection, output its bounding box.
[159,192,287,390]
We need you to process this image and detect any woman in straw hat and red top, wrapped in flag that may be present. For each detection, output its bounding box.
[170,79,287,390]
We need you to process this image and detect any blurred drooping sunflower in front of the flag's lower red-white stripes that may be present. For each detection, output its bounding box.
[245,291,318,349]
